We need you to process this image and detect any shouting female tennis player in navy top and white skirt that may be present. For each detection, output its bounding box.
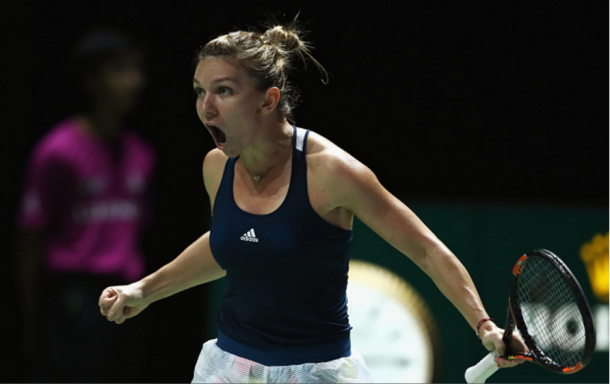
[99,18,524,383]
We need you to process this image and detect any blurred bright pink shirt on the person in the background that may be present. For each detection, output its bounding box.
[19,120,155,282]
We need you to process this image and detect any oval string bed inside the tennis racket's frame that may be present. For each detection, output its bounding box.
[518,257,586,367]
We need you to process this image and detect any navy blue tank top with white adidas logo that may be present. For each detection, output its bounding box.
[210,127,352,366]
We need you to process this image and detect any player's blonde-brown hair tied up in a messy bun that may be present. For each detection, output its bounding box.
[195,18,328,121]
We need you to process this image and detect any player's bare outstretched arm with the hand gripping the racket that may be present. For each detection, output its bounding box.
[333,159,525,367]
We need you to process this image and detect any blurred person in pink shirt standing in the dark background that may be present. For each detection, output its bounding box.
[17,28,155,382]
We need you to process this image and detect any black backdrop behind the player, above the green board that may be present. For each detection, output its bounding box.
[0,0,609,382]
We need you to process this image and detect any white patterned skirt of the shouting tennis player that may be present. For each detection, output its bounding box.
[192,339,373,383]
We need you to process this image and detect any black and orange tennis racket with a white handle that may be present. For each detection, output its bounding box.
[464,249,595,383]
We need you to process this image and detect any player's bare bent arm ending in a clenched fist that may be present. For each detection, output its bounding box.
[99,150,227,324]
